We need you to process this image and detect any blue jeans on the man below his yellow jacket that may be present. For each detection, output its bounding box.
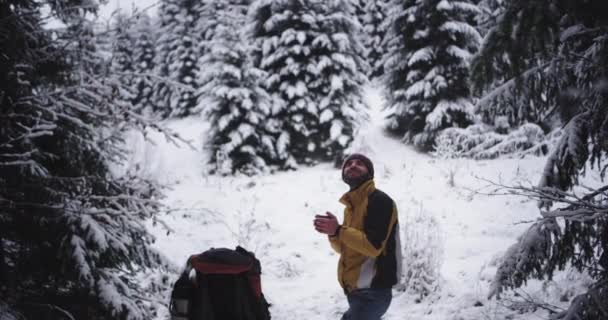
[342,289,393,320]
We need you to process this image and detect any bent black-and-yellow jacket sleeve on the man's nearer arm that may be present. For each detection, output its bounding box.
[338,193,397,257]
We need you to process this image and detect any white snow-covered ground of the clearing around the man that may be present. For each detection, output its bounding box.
[131,89,596,320]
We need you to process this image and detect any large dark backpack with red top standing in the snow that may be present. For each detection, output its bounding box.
[169,246,270,320]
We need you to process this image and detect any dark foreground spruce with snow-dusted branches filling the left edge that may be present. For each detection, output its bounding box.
[0,0,171,320]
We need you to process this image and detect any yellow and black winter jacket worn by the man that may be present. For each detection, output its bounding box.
[329,180,401,292]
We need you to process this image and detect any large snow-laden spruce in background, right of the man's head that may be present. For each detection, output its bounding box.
[384,0,481,151]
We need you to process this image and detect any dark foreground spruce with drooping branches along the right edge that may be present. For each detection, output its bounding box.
[475,0,608,319]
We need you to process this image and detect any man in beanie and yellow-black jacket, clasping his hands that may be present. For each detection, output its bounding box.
[314,154,401,320]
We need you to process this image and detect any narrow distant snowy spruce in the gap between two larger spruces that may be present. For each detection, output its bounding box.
[362,0,388,79]
